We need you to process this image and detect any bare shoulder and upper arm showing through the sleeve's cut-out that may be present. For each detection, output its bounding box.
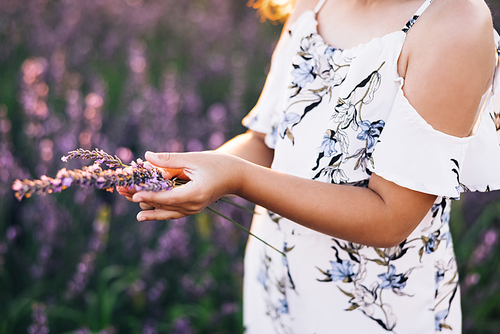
[399,0,496,137]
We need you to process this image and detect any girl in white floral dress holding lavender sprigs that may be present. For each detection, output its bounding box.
[120,0,500,334]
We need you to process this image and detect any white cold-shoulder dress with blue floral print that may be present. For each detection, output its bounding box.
[243,0,500,334]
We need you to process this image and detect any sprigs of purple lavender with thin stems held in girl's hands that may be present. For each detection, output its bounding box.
[12,148,286,257]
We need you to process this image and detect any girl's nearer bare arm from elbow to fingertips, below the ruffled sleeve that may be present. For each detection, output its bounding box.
[133,151,436,247]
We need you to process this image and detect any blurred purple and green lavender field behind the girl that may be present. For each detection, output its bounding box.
[0,0,500,334]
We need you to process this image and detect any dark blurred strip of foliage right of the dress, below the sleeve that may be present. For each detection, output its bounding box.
[451,192,500,334]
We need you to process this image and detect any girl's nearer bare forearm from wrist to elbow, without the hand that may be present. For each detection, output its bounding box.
[232,157,435,247]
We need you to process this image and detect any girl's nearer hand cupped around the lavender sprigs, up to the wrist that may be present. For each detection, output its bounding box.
[125,152,243,221]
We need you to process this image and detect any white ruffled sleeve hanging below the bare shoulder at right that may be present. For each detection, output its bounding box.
[369,63,500,199]
